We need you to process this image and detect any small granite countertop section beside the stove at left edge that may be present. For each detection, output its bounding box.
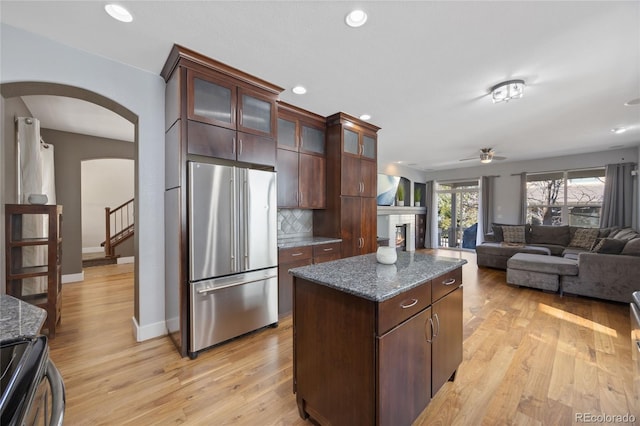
[0,294,47,340]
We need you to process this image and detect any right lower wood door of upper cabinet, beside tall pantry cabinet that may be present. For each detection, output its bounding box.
[298,153,327,209]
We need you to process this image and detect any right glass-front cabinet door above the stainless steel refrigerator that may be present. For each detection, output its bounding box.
[238,88,276,136]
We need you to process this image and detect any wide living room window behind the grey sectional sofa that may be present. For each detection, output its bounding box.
[527,168,605,228]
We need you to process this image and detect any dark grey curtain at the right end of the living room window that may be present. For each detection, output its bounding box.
[600,163,635,228]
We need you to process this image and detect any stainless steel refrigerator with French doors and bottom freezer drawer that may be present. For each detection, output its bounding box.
[188,162,278,357]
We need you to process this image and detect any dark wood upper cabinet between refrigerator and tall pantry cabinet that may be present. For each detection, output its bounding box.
[276,102,326,209]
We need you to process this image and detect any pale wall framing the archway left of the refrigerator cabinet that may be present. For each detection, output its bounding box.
[0,24,170,340]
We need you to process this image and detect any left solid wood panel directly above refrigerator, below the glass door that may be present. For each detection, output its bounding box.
[187,120,236,160]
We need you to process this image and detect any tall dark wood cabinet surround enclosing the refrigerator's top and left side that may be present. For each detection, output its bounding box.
[161,45,283,356]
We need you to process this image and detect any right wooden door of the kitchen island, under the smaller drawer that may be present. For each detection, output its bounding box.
[431,286,462,396]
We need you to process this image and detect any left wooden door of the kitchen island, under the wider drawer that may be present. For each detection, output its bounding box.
[377,308,431,426]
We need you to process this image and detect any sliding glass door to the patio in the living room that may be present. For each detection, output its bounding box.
[437,181,479,249]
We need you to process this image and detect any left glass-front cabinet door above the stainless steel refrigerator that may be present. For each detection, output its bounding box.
[187,70,236,129]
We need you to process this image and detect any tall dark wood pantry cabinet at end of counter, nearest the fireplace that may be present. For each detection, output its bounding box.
[313,112,380,257]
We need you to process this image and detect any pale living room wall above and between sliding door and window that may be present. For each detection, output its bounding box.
[425,147,640,224]
